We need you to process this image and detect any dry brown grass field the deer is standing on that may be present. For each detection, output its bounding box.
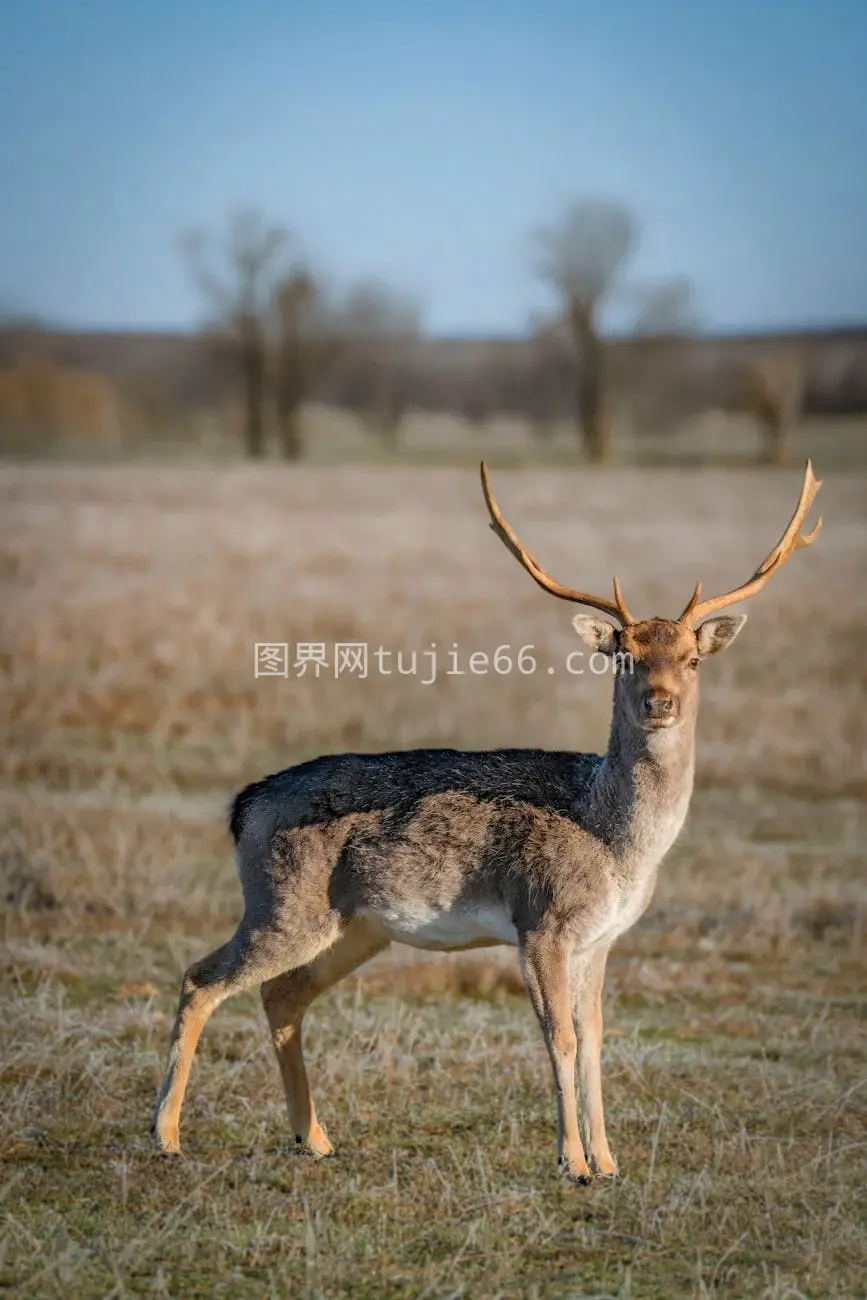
[0,452,867,1300]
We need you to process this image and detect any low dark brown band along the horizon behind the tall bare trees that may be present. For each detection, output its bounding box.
[0,326,867,460]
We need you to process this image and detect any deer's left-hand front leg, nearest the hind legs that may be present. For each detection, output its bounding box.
[520,932,591,1183]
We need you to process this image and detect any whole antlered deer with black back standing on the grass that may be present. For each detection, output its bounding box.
[152,462,822,1184]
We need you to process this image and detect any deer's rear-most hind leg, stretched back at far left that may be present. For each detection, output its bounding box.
[152,913,342,1154]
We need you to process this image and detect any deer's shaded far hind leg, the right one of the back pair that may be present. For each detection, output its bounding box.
[261,920,389,1158]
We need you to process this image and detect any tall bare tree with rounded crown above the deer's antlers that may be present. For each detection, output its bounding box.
[534,199,638,462]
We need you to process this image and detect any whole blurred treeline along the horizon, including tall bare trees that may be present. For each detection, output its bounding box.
[6,195,867,464]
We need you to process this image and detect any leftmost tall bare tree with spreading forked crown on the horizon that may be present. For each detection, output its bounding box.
[182,208,289,458]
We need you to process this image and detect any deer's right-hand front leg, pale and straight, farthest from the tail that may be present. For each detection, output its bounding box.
[571,949,617,1177]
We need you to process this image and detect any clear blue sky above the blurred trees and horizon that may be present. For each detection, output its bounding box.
[0,0,867,334]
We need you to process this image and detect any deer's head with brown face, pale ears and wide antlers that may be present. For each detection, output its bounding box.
[481,460,822,731]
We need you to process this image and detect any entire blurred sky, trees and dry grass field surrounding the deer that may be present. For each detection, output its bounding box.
[0,0,867,1300]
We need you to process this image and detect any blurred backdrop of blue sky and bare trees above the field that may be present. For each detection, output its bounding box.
[0,0,867,465]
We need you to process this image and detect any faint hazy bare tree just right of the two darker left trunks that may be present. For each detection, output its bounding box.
[343,278,421,451]
